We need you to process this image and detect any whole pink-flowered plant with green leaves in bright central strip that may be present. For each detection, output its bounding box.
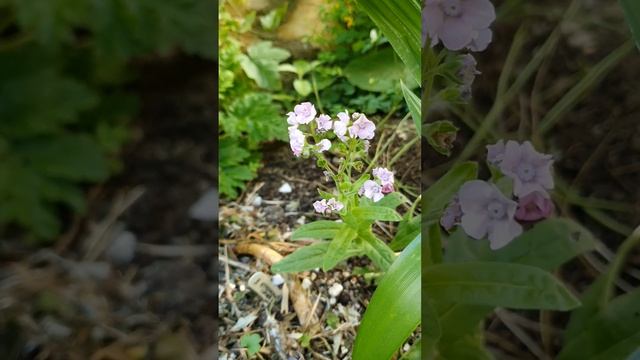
[272,102,408,272]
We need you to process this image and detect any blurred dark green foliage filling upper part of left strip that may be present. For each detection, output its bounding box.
[0,0,216,240]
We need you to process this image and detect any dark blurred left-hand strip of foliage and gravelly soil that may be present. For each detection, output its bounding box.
[0,0,217,359]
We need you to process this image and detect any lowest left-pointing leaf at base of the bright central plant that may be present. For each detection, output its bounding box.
[271,241,362,273]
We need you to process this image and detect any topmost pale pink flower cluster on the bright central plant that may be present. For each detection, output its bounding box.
[287,102,376,157]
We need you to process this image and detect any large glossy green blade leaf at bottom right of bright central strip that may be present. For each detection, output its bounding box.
[353,237,422,360]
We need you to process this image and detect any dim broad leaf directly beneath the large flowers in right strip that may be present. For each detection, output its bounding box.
[445,218,596,270]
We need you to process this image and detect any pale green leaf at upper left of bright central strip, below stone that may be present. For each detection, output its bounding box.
[240,41,291,90]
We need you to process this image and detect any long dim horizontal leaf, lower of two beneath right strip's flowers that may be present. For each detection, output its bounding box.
[423,262,580,311]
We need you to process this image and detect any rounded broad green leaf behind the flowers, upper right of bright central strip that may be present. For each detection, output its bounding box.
[343,48,418,92]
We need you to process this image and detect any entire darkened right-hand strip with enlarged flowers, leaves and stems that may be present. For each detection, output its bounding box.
[422,0,640,359]
